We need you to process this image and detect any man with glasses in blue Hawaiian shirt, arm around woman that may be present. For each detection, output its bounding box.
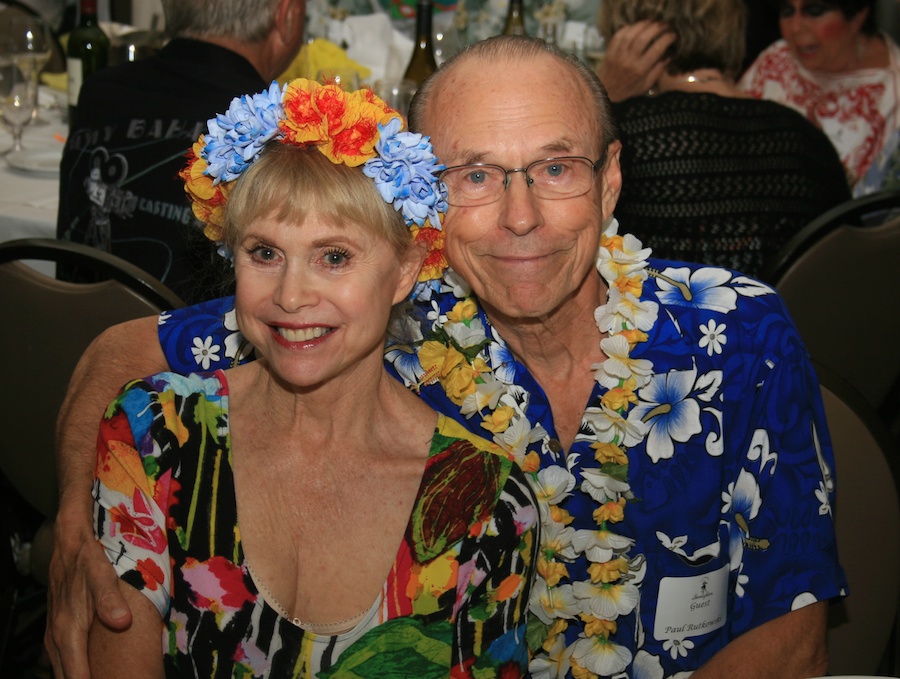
[44,37,846,678]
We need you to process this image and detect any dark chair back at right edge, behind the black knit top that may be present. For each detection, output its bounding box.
[766,191,900,421]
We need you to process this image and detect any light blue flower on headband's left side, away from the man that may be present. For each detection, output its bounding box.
[203,82,284,184]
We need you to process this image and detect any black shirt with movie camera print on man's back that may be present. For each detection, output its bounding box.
[56,38,268,302]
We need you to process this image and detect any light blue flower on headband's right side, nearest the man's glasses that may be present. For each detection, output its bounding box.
[363,118,447,229]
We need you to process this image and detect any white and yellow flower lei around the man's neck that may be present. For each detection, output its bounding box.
[408,222,658,678]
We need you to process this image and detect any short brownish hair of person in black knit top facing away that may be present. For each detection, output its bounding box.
[598,0,747,78]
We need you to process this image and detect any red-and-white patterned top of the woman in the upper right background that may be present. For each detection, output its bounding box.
[740,34,900,195]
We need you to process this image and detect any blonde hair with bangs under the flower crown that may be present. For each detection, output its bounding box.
[223,141,413,256]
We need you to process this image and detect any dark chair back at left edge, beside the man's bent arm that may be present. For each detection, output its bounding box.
[0,239,184,517]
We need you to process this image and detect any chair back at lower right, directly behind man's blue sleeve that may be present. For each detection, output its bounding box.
[816,365,900,675]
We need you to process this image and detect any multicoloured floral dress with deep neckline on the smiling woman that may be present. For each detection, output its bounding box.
[94,371,539,679]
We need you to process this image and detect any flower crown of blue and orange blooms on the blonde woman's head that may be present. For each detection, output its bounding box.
[179,78,447,282]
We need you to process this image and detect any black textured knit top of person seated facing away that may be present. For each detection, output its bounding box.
[613,92,850,276]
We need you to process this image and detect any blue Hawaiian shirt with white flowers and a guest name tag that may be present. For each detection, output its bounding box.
[159,259,847,678]
